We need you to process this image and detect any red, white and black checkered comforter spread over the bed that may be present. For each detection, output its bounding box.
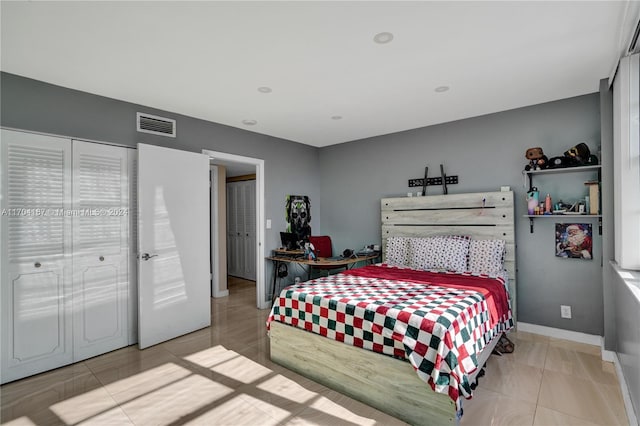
[267,264,513,409]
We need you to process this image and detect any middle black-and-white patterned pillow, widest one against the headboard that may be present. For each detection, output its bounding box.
[408,235,470,271]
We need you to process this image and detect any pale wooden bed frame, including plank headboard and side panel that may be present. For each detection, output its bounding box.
[270,191,517,425]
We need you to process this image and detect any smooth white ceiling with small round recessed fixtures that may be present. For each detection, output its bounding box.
[1,1,638,147]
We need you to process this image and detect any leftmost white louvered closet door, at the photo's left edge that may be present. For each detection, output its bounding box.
[0,129,73,383]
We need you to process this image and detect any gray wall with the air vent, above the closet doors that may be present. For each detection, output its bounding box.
[0,73,320,302]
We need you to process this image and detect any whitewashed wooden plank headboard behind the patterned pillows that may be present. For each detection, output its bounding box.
[381,191,517,324]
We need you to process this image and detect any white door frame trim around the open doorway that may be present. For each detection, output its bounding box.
[202,149,269,309]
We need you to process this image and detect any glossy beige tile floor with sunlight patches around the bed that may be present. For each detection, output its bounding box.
[0,279,627,426]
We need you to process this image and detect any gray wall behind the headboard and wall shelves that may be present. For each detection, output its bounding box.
[320,93,604,335]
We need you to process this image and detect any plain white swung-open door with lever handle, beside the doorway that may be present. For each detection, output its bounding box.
[138,144,211,349]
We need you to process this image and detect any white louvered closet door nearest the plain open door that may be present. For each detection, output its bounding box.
[72,140,131,361]
